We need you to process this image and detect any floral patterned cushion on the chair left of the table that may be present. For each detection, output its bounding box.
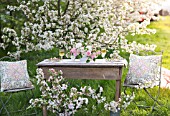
[0,60,33,91]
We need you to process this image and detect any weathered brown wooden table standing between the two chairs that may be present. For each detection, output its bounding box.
[37,59,125,116]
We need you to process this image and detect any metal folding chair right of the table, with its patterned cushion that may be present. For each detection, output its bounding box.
[123,51,163,111]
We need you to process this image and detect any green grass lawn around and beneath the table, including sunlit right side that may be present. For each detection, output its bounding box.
[0,16,170,116]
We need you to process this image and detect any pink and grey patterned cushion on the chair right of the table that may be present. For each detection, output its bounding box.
[126,54,161,86]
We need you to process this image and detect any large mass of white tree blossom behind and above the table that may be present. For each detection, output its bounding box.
[0,0,161,57]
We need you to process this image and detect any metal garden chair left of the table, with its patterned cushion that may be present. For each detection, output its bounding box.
[0,56,37,116]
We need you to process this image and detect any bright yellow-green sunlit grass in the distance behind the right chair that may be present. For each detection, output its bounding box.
[127,16,170,69]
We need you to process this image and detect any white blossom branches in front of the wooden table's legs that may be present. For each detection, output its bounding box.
[29,69,134,116]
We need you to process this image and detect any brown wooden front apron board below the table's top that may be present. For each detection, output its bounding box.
[40,67,121,80]
